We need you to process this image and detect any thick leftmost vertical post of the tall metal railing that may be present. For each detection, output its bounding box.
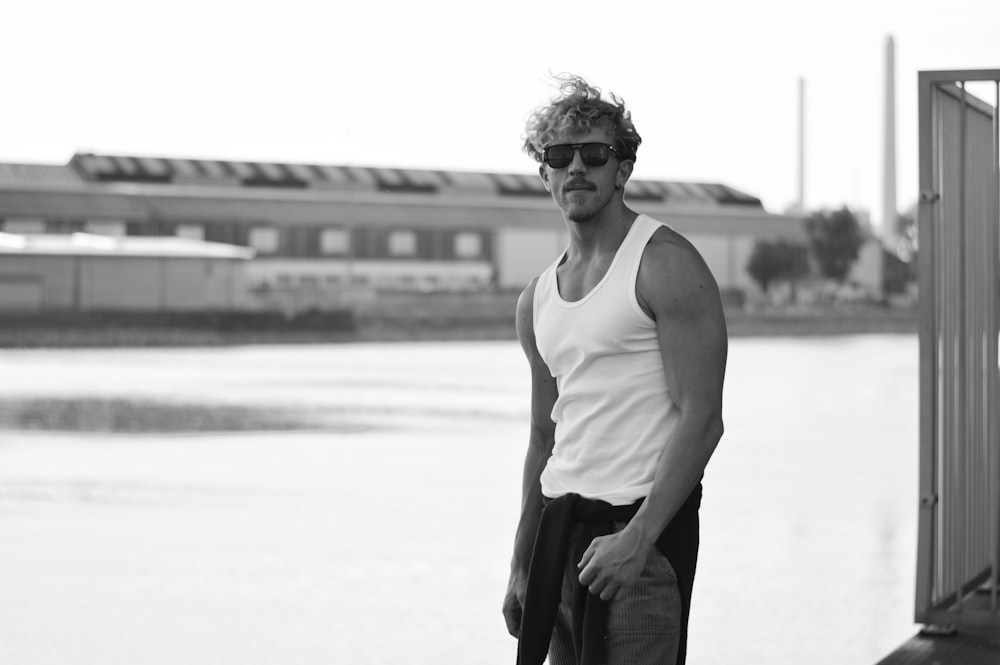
[915,72,940,623]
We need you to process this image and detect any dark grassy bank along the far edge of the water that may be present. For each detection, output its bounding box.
[0,294,917,348]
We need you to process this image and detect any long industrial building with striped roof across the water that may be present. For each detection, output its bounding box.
[0,153,804,310]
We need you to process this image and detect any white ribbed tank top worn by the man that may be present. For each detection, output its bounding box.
[533,215,679,505]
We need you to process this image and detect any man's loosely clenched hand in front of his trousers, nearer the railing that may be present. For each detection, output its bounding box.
[577,527,654,600]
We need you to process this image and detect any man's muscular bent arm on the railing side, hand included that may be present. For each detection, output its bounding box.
[579,229,728,600]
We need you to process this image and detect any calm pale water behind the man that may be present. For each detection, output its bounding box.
[0,336,918,665]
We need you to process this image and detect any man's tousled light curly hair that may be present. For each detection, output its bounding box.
[522,74,642,162]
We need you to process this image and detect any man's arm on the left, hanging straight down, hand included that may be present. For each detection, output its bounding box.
[503,282,558,637]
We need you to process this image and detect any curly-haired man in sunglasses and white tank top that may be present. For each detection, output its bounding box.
[503,76,727,665]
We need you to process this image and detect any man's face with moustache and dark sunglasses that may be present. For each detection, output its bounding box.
[539,128,631,223]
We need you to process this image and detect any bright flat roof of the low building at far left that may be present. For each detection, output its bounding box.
[0,233,254,259]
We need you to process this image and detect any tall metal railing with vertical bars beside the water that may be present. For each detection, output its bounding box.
[916,69,1000,626]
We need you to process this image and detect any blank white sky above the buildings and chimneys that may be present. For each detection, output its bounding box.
[0,0,1000,230]
